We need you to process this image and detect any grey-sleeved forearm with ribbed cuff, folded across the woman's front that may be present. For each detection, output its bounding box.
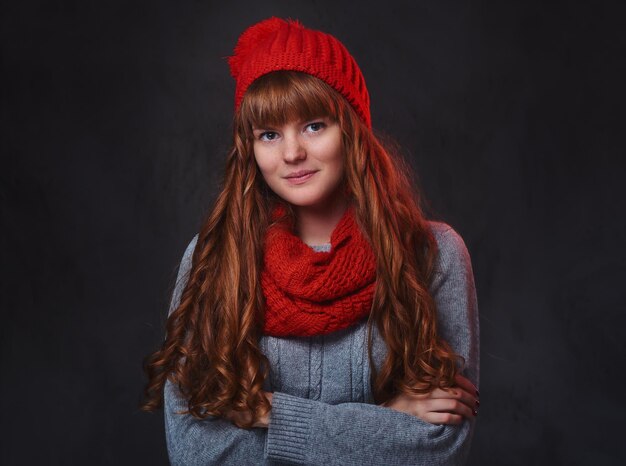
[267,392,473,465]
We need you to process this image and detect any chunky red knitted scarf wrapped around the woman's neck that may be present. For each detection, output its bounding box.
[261,208,376,336]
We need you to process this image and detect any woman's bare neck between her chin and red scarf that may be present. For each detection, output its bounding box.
[296,197,348,245]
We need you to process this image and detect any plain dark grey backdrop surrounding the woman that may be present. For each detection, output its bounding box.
[0,0,626,465]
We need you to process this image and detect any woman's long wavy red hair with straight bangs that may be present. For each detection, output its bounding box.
[142,71,459,428]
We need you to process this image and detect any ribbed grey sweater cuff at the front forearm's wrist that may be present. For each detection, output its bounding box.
[267,392,313,464]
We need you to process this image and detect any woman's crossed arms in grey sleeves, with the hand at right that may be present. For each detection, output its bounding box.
[165,227,478,465]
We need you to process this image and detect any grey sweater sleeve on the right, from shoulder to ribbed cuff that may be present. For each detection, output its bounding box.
[267,223,478,465]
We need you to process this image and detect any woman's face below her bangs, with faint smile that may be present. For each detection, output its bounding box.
[252,118,344,208]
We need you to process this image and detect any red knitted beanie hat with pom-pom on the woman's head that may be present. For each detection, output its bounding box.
[228,18,372,127]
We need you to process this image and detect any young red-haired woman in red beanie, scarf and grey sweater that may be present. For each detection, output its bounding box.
[144,18,479,465]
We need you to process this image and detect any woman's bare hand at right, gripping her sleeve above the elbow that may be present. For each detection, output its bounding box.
[381,375,480,424]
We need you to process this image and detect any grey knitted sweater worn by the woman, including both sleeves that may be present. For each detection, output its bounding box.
[165,222,478,465]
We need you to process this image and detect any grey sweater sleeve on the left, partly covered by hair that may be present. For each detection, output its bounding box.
[164,237,275,466]
